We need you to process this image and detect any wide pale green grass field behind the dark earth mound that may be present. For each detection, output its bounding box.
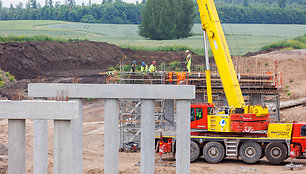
[0,21,306,55]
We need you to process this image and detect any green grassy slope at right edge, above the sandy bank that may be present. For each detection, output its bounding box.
[261,34,306,50]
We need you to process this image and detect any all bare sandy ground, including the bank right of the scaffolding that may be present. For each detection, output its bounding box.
[0,50,306,174]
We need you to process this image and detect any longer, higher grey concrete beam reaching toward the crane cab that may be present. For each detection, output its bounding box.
[28,83,195,99]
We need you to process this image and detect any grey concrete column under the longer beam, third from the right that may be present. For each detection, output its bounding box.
[104,99,120,174]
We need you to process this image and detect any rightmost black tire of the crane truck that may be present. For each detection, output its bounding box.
[265,143,288,164]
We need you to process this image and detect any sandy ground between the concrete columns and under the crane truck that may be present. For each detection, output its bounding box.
[0,100,306,174]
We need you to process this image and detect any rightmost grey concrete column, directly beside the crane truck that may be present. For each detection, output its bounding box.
[176,100,190,174]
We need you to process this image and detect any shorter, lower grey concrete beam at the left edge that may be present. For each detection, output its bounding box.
[0,100,80,120]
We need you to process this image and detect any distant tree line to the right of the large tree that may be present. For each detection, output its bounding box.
[195,3,306,24]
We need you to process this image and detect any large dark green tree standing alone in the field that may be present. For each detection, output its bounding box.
[138,0,194,40]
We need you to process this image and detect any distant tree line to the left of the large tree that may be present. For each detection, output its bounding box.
[0,0,143,24]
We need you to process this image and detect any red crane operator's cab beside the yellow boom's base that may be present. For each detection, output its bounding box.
[190,103,214,130]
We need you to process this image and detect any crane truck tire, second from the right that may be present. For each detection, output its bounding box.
[239,142,262,164]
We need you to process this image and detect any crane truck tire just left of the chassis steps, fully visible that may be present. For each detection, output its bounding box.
[203,142,225,163]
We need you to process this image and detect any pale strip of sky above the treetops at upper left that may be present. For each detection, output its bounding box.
[2,0,141,7]
